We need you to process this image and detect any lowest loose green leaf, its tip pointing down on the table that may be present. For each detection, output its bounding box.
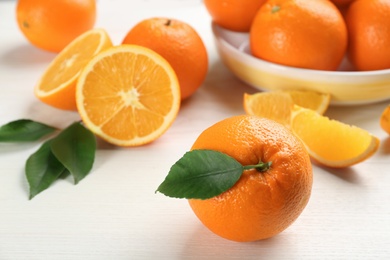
[25,140,66,199]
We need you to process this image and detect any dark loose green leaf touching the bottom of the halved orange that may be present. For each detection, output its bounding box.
[51,122,96,184]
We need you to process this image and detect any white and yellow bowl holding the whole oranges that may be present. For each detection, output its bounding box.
[212,23,390,105]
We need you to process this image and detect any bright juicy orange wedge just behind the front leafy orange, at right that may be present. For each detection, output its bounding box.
[291,106,379,168]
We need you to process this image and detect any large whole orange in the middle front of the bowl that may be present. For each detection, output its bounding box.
[250,0,347,70]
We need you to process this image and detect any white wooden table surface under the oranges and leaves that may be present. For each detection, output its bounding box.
[0,0,390,260]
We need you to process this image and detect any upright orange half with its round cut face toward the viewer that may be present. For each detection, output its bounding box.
[76,44,180,146]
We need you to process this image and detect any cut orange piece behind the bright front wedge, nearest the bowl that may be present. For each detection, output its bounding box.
[244,90,330,126]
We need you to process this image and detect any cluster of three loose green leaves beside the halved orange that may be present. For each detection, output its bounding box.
[0,119,96,199]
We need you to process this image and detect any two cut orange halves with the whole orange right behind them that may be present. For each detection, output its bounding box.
[29,18,208,146]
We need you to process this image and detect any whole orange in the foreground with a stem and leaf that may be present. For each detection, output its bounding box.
[189,115,312,241]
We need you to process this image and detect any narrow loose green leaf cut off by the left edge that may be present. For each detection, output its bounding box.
[0,119,56,142]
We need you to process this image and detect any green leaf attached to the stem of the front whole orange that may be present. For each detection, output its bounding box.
[156,150,243,199]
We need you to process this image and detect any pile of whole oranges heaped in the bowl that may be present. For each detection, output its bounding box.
[204,0,390,71]
